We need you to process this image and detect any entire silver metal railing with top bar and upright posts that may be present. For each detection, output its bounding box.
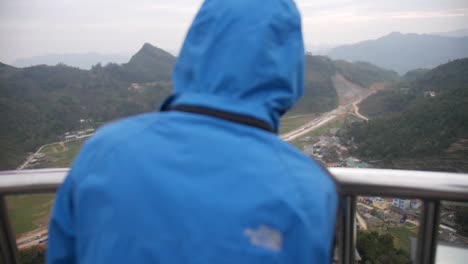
[0,168,468,264]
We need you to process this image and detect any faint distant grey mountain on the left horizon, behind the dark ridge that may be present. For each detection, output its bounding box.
[12,52,129,70]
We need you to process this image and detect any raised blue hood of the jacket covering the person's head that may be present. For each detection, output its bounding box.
[163,0,304,131]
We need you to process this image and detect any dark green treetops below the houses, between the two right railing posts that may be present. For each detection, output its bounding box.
[356,232,411,264]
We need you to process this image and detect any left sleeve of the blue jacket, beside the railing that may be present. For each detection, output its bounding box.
[46,172,76,264]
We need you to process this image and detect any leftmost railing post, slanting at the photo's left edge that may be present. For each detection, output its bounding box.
[0,196,18,264]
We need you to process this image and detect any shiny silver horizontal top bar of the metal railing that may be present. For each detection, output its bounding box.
[0,168,468,201]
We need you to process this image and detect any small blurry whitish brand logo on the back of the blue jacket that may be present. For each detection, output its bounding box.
[244,225,283,252]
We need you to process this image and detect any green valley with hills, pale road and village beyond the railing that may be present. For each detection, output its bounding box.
[0,37,468,264]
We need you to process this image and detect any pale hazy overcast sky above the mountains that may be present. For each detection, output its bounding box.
[0,0,468,63]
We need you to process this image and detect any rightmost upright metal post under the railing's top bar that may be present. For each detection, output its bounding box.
[416,200,440,264]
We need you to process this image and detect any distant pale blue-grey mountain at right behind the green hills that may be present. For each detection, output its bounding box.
[328,32,468,74]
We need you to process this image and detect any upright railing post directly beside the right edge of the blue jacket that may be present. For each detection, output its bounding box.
[338,196,356,264]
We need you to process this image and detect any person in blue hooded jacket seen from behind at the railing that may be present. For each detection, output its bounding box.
[47,0,337,264]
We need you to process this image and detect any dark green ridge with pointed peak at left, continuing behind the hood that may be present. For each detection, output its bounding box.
[0,43,397,169]
